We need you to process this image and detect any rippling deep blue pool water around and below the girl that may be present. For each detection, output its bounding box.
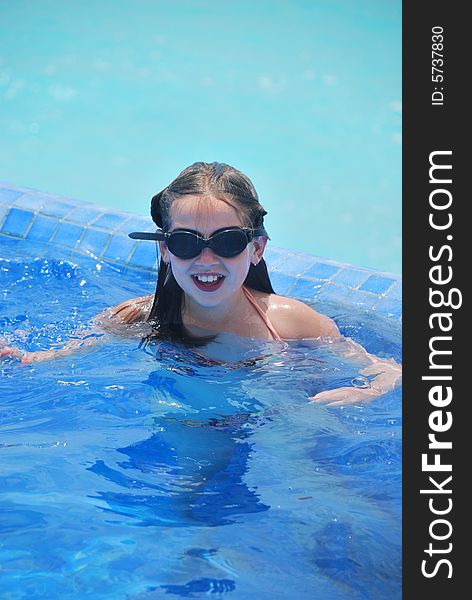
[0,237,401,600]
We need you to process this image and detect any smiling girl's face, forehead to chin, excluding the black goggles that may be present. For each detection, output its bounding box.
[159,196,267,308]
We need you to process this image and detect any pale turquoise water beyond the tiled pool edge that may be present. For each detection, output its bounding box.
[0,0,401,273]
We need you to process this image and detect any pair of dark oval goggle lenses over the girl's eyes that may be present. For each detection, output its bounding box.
[167,229,249,259]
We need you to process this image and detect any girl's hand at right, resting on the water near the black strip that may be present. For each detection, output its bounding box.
[309,358,402,406]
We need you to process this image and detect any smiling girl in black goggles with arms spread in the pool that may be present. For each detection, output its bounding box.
[0,162,401,404]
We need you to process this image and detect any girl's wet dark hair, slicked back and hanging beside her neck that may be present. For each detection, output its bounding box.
[147,162,274,347]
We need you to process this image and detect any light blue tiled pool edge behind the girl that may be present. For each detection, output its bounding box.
[0,182,402,321]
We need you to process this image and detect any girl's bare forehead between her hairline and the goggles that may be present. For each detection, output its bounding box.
[170,196,243,235]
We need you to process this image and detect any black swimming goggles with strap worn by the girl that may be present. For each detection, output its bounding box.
[128,227,268,260]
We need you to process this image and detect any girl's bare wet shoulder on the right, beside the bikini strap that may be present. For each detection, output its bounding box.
[261,294,340,340]
